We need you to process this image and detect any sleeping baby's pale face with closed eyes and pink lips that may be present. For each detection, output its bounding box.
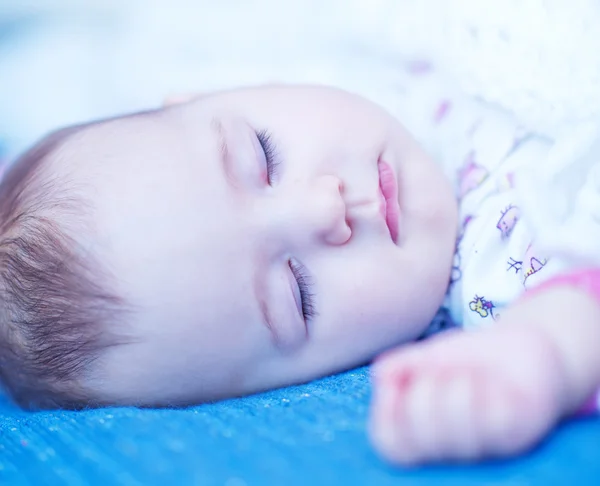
[74,87,456,405]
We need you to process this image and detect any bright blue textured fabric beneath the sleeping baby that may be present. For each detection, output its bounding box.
[0,368,600,486]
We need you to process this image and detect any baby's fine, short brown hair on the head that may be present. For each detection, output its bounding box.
[0,129,124,408]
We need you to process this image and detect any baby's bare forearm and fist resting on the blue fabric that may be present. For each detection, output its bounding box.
[371,272,600,464]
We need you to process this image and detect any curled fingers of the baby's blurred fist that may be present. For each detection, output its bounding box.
[371,360,503,465]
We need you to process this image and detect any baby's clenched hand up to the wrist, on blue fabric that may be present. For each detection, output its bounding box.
[371,322,566,465]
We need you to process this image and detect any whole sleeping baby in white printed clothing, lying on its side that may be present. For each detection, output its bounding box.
[0,2,600,464]
